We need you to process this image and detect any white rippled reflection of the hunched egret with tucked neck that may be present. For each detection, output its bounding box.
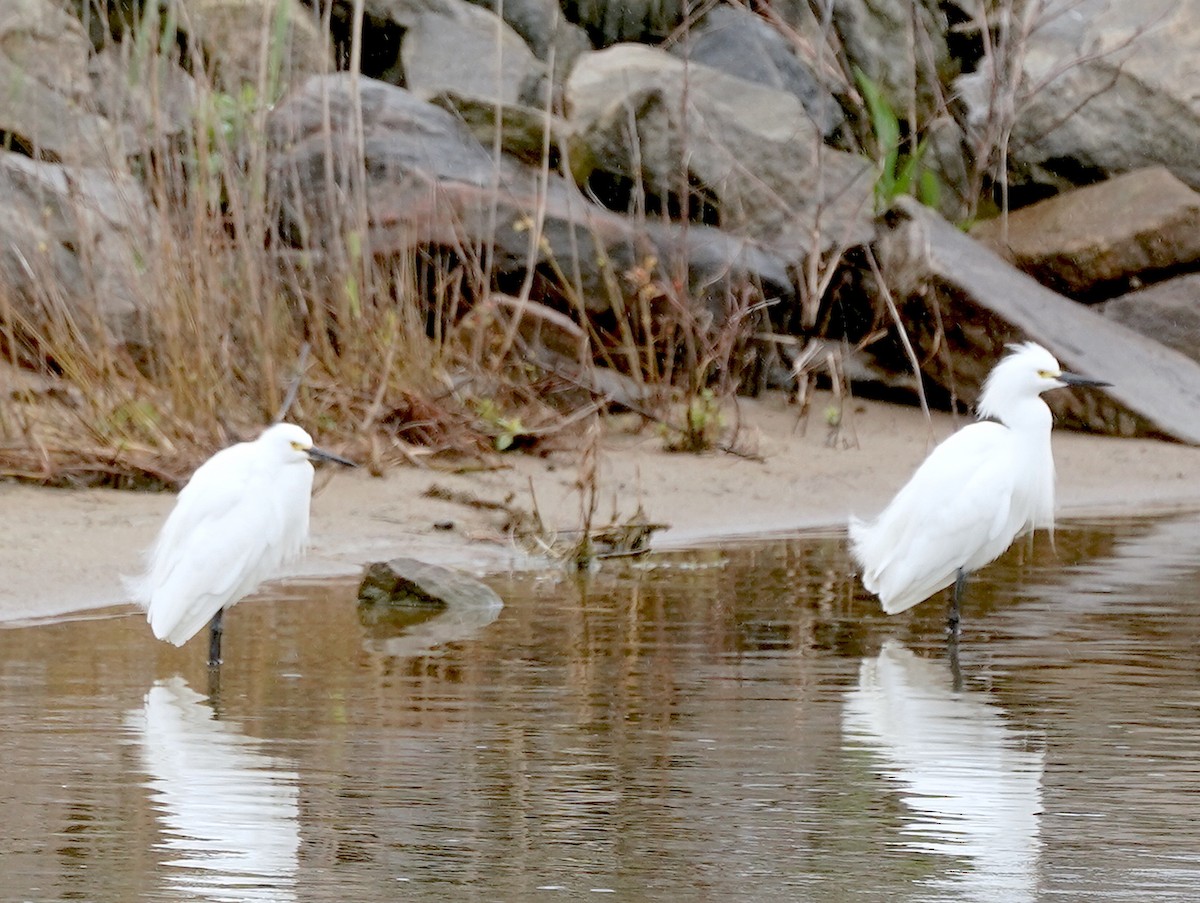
[127,677,300,902]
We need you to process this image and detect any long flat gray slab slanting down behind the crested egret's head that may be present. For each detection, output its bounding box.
[880,201,1200,444]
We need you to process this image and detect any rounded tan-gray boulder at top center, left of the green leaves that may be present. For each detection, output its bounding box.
[566,44,874,261]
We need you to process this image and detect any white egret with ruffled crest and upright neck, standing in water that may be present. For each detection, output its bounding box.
[850,342,1109,636]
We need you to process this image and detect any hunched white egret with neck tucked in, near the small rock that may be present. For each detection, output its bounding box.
[127,424,355,665]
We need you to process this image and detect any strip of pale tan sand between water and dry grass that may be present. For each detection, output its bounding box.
[0,396,1200,623]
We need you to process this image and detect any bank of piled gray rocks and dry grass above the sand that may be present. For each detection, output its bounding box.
[0,0,1200,485]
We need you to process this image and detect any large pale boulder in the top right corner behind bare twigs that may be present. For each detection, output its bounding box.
[959,0,1200,189]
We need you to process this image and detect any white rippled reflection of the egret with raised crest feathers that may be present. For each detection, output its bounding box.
[842,640,1045,902]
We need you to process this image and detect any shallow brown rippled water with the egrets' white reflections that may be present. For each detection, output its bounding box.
[0,516,1200,903]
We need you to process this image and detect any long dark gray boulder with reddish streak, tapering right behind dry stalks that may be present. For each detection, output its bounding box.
[268,76,790,313]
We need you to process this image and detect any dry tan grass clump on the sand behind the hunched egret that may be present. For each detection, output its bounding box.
[0,90,752,489]
